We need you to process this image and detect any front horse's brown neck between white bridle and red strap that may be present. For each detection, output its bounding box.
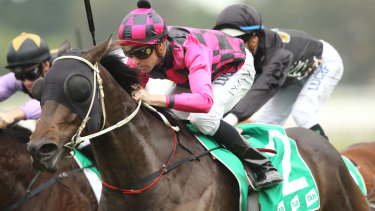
[91,74,173,184]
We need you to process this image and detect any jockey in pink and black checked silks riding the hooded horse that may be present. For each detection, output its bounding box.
[117,0,282,189]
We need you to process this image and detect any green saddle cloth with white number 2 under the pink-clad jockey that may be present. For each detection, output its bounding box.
[188,124,320,211]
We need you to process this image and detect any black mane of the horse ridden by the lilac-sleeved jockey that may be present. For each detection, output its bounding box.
[0,124,31,143]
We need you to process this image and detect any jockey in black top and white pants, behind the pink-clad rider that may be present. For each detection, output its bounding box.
[214,4,344,138]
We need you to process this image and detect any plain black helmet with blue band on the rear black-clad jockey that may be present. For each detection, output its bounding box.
[214,4,264,37]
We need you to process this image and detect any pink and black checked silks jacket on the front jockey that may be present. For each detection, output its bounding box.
[122,27,246,112]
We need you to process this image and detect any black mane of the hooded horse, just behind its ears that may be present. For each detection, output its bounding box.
[100,44,141,93]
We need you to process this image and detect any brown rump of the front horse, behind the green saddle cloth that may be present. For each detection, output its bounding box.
[286,128,369,211]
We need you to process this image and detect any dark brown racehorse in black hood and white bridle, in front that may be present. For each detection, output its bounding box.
[28,39,368,211]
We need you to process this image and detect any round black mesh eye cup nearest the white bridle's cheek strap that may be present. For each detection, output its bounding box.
[64,73,92,104]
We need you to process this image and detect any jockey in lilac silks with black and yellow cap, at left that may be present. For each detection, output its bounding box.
[0,32,95,166]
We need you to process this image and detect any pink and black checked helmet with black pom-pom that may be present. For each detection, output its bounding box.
[117,0,168,46]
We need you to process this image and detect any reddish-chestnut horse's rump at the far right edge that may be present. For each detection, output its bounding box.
[340,142,375,210]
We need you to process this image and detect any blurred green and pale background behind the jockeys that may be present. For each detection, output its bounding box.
[0,0,375,149]
